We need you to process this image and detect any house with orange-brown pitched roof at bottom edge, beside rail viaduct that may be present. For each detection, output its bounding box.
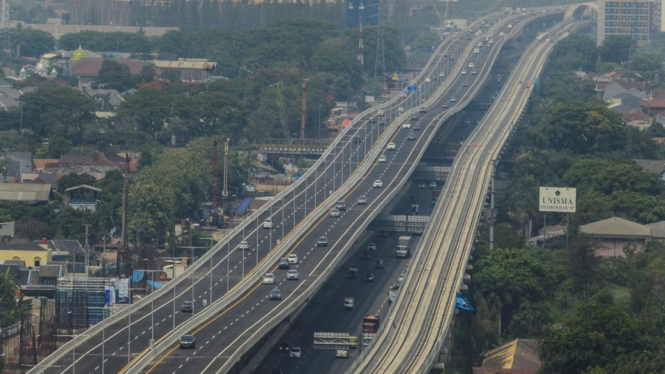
[473,339,542,374]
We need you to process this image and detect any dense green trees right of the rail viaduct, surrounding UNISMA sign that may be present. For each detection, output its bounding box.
[463,31,665,374]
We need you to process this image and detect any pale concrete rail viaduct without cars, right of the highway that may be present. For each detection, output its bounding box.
[347,16,579,374]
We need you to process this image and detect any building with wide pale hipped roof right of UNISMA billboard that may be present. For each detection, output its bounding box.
[579,217,653,257]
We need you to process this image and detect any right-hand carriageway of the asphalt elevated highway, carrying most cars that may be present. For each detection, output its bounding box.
[130,8,550,373]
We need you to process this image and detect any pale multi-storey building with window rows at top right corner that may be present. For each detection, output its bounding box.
[598,0,661,45]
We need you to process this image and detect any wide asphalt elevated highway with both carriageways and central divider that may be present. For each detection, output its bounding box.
[31,8,564,373]
